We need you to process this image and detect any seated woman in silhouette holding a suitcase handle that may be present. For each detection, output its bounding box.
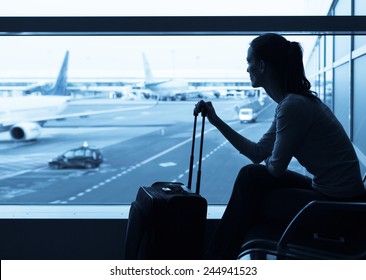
[196,33,365,259]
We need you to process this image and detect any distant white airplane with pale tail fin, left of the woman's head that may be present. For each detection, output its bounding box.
[142,53,190,101]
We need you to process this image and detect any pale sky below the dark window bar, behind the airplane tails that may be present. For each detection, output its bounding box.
[0,36,315,82]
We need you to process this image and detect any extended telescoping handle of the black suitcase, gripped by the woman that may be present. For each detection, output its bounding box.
[188,103,206,194]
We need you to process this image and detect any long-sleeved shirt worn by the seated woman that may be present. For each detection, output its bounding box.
[240,94,365,198]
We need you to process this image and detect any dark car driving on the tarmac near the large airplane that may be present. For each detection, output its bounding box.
[48,144,103,169]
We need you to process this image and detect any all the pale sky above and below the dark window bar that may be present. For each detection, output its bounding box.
[0,0,331,82]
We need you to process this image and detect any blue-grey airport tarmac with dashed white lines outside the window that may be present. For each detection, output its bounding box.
[0,100,306,204]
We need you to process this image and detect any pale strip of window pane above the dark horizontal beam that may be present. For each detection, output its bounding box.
[0,0,333,16]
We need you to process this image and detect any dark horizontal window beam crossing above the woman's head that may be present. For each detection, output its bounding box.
[0,16,366,36]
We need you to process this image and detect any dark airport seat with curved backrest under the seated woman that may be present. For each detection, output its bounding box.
[238,178,366,260]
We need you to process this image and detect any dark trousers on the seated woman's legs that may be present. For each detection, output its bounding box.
[206,164,338,259]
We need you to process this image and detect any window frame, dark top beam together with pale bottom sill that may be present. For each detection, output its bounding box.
[0,16,366,219]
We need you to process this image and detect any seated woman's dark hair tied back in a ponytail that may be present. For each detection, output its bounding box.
[250,33,317,98]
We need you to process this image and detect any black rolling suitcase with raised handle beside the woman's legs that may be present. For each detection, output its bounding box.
[125,106,207,260]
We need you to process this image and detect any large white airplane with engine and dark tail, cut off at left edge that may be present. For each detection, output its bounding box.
[0,51,154,141]
